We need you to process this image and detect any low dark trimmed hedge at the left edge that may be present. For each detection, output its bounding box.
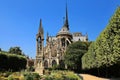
[0,52,27,71]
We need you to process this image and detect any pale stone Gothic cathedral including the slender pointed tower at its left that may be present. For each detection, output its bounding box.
[35,7,88,74]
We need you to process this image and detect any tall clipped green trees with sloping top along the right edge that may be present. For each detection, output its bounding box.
[82,7,120,76]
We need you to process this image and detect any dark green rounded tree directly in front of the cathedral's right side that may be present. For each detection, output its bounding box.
[65,41,90,72]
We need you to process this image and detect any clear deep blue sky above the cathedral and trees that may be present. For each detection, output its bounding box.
[0,0,120,58]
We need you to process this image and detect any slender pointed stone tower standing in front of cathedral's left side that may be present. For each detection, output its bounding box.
[35,19,44,75]
